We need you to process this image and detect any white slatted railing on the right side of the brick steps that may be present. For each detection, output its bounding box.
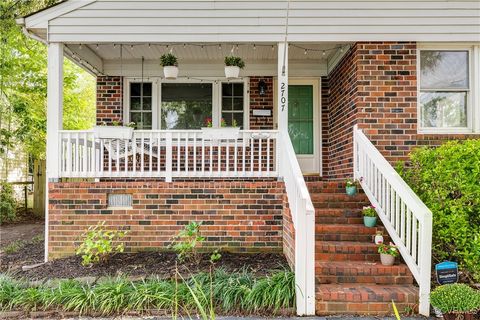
[353,126,432,316]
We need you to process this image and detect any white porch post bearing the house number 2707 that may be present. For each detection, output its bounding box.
[277,42,288,132]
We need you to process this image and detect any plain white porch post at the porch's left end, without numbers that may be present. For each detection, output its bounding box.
[45,43,63,262]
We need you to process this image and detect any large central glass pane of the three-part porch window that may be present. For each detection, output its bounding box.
[161,83,213,129]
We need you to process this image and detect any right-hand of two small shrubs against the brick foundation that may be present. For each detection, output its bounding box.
[170,221,205,263]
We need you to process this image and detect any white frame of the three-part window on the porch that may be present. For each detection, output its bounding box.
[123,77,250,130]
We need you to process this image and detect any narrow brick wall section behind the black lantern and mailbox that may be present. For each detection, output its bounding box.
[250,77,273,130]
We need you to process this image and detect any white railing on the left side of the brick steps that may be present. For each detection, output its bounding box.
[279,131,315,316]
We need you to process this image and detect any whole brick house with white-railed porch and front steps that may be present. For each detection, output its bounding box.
[18,0,480,315]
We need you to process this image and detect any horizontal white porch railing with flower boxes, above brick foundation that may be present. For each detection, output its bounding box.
[59,130,278,181]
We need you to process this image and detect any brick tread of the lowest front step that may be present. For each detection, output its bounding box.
[316,283,418,304]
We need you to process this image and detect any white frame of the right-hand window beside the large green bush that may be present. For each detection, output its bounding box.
[417,43,480,134]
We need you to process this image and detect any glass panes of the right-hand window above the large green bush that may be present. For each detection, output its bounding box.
[419,50,470,129]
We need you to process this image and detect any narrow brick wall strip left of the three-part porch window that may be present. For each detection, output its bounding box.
[97,76,123,124]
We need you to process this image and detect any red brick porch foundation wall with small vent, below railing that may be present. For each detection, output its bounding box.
[48,181,284,258]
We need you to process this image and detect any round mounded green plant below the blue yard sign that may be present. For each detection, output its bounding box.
[430,283,480,320]
